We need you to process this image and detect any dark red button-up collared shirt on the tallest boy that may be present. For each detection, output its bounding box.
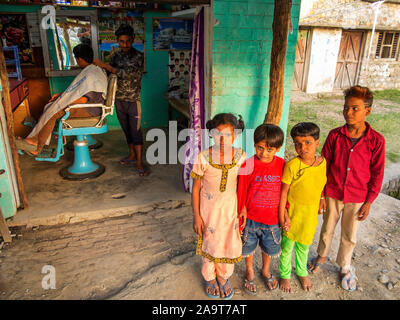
[322,122,385,203]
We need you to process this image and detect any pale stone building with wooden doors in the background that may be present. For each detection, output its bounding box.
[293,0,400,93]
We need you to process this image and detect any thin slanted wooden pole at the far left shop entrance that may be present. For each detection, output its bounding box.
[0,41,28,209]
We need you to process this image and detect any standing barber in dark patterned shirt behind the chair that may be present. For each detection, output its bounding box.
[93,24,148,176]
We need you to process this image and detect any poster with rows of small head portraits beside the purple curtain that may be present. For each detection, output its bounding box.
[167,50,192,99]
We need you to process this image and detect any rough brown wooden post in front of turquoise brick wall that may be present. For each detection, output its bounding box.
[264,0,292,126]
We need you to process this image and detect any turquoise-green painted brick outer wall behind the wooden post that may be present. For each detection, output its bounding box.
[211,0,301,156]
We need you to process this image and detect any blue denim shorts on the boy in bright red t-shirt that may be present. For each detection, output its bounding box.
[242,219,282,257]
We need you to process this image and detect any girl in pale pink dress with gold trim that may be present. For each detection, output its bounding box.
[191,113,246,300]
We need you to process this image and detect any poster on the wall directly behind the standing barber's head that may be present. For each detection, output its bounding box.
[98,10,145,63]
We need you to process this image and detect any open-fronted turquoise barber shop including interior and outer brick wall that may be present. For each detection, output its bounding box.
[0,0,300,227]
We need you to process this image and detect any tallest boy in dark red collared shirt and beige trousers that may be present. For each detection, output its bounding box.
[309,86,385,291]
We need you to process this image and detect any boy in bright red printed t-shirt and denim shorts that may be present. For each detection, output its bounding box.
[237,124,285,295]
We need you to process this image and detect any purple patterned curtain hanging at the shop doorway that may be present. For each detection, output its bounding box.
[182,8,204,191]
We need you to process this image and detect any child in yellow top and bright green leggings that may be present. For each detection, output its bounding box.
[279,122,326,293]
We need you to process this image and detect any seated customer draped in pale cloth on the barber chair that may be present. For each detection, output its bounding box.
[16,44,107,156]
